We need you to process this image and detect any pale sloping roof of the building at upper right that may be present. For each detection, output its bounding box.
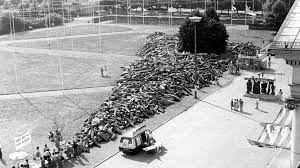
[270,0,300,50]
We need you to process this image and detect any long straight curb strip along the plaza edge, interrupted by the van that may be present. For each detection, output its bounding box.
[92,73,238,168]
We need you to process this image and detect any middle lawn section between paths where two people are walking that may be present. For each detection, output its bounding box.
[0,52,135,94]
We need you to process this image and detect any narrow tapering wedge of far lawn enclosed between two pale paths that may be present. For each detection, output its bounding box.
[16,33,147,56]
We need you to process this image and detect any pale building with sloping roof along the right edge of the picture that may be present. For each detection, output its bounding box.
[270,0,300,168]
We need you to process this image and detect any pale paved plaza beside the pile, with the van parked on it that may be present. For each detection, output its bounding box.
[97,58,291,168]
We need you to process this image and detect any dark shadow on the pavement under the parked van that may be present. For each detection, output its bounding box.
[122,147,168,163]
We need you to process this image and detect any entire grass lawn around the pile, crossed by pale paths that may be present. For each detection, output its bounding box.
[0,25,273,167]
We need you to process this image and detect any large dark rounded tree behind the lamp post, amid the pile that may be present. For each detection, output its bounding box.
[179,11,229,54]
